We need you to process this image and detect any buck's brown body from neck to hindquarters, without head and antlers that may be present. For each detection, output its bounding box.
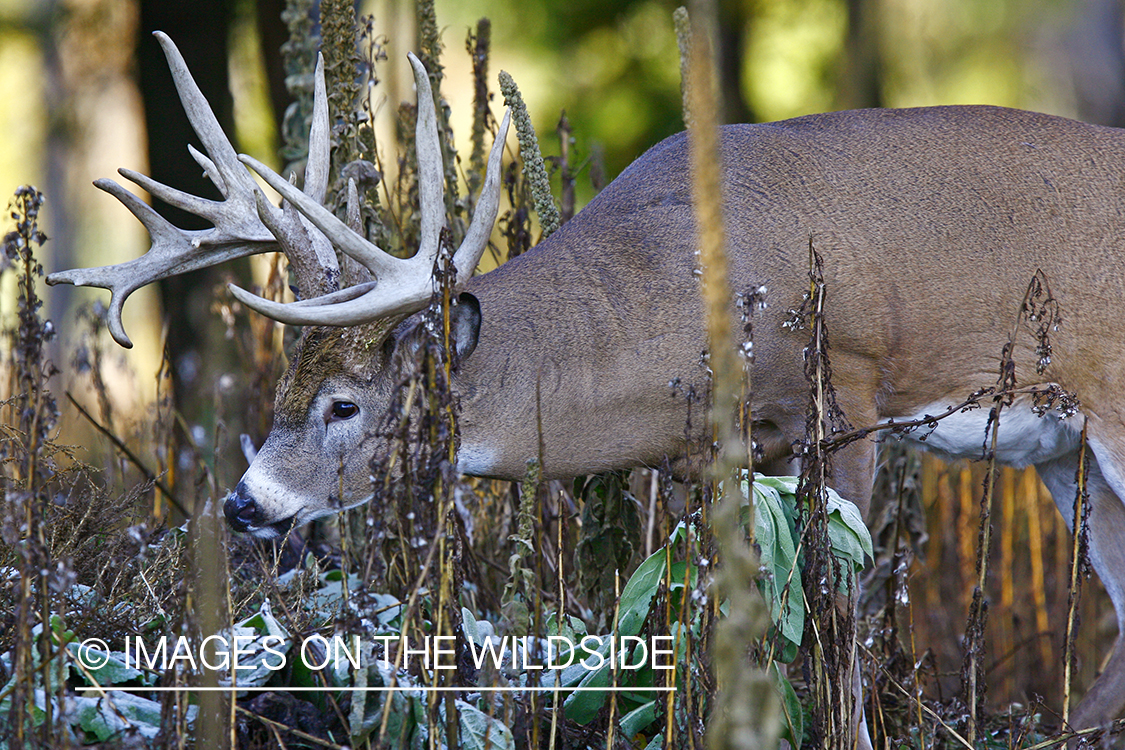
[434,107,1125,726]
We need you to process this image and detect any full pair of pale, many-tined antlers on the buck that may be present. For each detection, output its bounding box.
[47,31,509,349]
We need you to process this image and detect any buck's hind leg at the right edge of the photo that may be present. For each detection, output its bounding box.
[1035,445,1125,729]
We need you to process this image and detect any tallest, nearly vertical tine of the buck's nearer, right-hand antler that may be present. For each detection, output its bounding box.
[406,52,446,266]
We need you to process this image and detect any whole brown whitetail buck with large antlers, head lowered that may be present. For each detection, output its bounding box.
[48,30,1125,746]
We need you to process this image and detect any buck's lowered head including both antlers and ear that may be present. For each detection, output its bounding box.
[47,31,509,537]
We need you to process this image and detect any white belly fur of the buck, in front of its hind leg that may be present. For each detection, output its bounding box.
[888,397,1082,467]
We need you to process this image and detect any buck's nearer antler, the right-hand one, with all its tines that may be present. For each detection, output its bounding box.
[231,54,510,326]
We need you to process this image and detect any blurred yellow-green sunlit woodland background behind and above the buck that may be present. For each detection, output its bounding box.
[0,0,1125,396]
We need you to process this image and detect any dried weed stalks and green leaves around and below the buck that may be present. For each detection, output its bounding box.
[0,2,1120,749]
